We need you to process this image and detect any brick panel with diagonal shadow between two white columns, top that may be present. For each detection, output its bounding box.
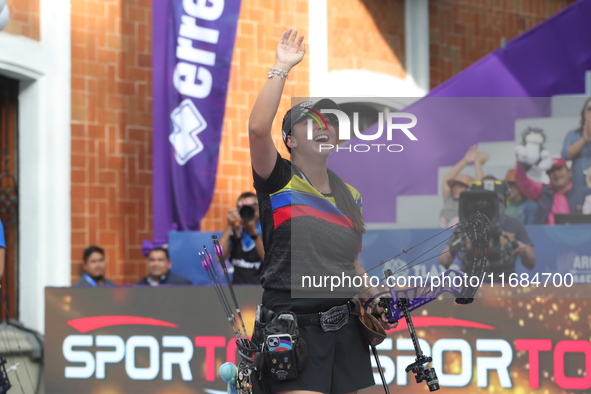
[328,0,406,79]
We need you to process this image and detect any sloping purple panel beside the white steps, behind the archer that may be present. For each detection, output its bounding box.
[329,0,591,223]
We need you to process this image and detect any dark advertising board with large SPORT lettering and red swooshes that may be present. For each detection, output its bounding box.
[45,286,591,394]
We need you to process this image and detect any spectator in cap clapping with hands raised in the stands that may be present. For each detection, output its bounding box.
[439,145,488,228]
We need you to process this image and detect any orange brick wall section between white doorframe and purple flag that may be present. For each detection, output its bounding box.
[71,0,152,283]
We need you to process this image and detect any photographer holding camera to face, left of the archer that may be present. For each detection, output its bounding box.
[220,192,265,284]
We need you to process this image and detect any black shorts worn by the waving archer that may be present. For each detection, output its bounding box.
[263,291,375,394]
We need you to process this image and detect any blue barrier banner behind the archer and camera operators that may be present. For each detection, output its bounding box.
[169,224,591,288]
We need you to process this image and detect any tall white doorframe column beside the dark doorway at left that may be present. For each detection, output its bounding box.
[0,0,71,332]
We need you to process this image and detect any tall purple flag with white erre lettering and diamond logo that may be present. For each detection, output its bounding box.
[153,0,240,244]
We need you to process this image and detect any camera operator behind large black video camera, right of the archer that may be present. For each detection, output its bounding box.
[439,177,536,280]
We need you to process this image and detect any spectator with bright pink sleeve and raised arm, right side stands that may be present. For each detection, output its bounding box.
[515,158,591,224]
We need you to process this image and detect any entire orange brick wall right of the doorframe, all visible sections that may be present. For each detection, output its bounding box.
[66,0,573,283]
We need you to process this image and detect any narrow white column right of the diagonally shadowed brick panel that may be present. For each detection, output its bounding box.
[404,0,430,92]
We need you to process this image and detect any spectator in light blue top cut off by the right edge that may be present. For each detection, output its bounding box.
[562,99,591,191]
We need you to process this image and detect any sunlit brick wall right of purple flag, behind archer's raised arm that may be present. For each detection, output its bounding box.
[201,0,309,231]
